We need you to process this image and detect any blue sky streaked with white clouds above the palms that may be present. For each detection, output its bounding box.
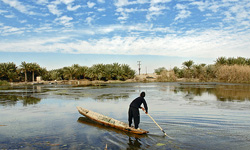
[0,0,250,73]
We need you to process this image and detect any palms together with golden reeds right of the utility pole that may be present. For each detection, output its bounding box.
[155,57,250,83]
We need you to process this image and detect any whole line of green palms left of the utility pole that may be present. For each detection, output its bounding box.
[0,61,135,82]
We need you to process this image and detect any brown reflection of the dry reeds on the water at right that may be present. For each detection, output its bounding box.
[173,85,250,102]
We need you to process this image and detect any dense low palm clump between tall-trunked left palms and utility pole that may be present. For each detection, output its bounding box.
[45,63,135,81]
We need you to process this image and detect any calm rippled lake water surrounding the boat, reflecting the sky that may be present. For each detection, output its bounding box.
[0,83,250,150]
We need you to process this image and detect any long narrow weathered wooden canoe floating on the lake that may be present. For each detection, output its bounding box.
[77,106,148,134]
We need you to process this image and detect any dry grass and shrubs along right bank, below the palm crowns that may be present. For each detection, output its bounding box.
[156,65,250,84]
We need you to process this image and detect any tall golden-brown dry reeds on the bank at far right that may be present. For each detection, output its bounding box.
[216,65,250,83]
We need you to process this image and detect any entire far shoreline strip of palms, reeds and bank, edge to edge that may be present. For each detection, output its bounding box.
[0,57,250,86]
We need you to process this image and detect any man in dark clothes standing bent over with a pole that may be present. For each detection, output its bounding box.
[128,92,148,129]
